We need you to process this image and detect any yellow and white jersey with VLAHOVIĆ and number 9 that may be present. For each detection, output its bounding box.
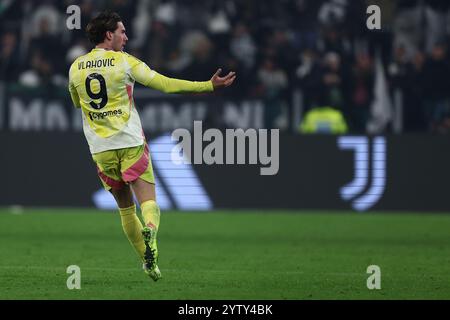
[69,48,214,154]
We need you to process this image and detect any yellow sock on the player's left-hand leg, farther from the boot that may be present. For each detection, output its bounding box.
[119,205,145,259]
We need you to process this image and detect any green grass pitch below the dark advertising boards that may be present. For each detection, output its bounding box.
[0,208,450,300]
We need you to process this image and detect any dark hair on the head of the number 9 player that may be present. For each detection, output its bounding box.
[86,11,122,44]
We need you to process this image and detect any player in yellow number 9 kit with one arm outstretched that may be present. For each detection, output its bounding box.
[69,12,236,281]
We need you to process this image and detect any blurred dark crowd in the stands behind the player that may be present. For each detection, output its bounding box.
[0,0,450,133]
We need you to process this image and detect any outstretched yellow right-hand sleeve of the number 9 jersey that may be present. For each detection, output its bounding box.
[125,55,214,93]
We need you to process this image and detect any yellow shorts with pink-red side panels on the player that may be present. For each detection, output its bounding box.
[92,143,155,190]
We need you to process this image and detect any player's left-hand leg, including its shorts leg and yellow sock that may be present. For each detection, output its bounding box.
[92,150,145,260]
